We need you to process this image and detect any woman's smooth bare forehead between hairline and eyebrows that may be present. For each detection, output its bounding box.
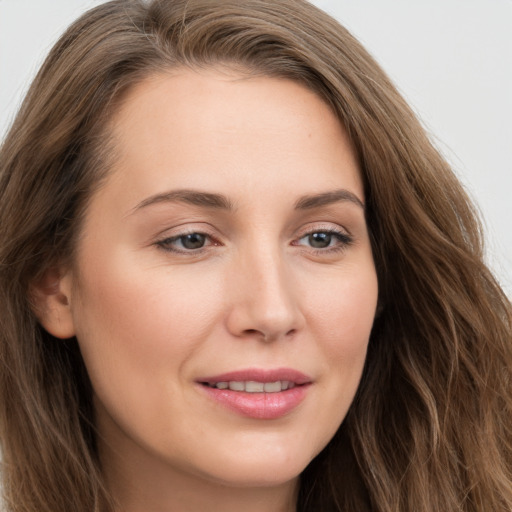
[100,68,363,208]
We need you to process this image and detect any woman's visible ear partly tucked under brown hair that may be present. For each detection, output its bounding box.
[30,267,75,339]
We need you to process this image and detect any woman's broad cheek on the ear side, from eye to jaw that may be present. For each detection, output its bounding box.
[68,258,228,448]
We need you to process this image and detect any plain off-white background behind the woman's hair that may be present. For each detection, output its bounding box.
[0,0,512,297]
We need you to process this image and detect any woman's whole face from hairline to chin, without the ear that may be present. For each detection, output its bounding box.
[62,69,377,492]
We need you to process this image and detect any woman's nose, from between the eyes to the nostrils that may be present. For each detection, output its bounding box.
[227,246,305,342]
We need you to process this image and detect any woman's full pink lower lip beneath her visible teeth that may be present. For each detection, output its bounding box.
[201,384,310,420]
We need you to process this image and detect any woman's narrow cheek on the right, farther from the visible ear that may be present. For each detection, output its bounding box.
[288,264,377,452]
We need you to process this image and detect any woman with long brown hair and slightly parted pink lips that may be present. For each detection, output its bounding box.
[0,0,512,512]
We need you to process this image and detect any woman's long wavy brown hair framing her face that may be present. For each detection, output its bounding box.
[0,0,512,512]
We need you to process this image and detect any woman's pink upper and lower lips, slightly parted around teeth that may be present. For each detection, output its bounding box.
[197,368,312,420]
